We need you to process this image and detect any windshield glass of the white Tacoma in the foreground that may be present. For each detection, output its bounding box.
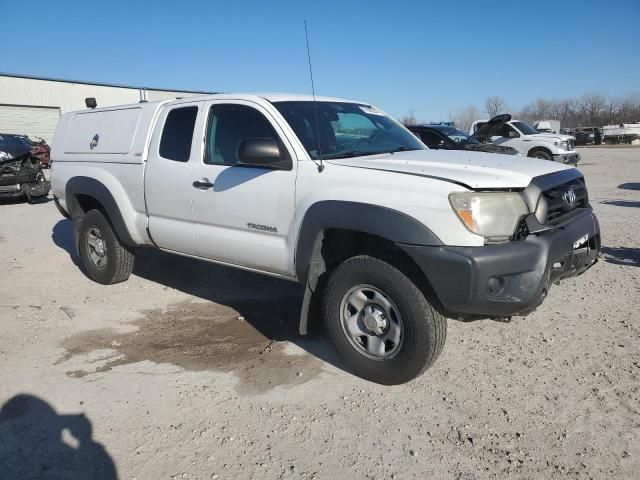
[274,102,425,160]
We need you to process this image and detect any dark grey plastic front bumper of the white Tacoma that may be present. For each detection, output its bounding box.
[399,210,600,319]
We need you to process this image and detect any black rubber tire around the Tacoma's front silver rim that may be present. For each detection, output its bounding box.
[323,255,447,385]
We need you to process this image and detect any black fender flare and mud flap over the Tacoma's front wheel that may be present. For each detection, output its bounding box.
[295,200,442,334]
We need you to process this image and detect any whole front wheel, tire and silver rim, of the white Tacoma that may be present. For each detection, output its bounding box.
[323,255,447,385]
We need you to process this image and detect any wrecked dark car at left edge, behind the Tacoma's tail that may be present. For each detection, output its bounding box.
[0,135,51,203]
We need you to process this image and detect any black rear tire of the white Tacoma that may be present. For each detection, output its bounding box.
[78,210,135,285]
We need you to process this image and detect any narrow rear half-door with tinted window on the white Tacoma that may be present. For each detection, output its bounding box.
[144,103,202,254]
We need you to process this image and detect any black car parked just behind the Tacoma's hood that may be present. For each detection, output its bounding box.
[407,119,519,155]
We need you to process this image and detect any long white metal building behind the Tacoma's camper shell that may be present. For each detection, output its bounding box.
[0,73,211,142]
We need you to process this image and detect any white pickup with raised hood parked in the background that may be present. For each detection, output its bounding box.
[469,115,580,165]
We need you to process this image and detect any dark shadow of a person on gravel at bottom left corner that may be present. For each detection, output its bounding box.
[0,394,118,480]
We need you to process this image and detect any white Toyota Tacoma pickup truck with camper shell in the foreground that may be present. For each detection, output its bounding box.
[51,94,600,384]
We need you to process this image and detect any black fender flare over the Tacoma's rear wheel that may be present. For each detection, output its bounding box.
[65,176,138,248]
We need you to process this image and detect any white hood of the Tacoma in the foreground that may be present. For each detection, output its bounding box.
[326,150,570,190]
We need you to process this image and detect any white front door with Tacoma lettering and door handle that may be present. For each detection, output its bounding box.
[191,100,297,275]
